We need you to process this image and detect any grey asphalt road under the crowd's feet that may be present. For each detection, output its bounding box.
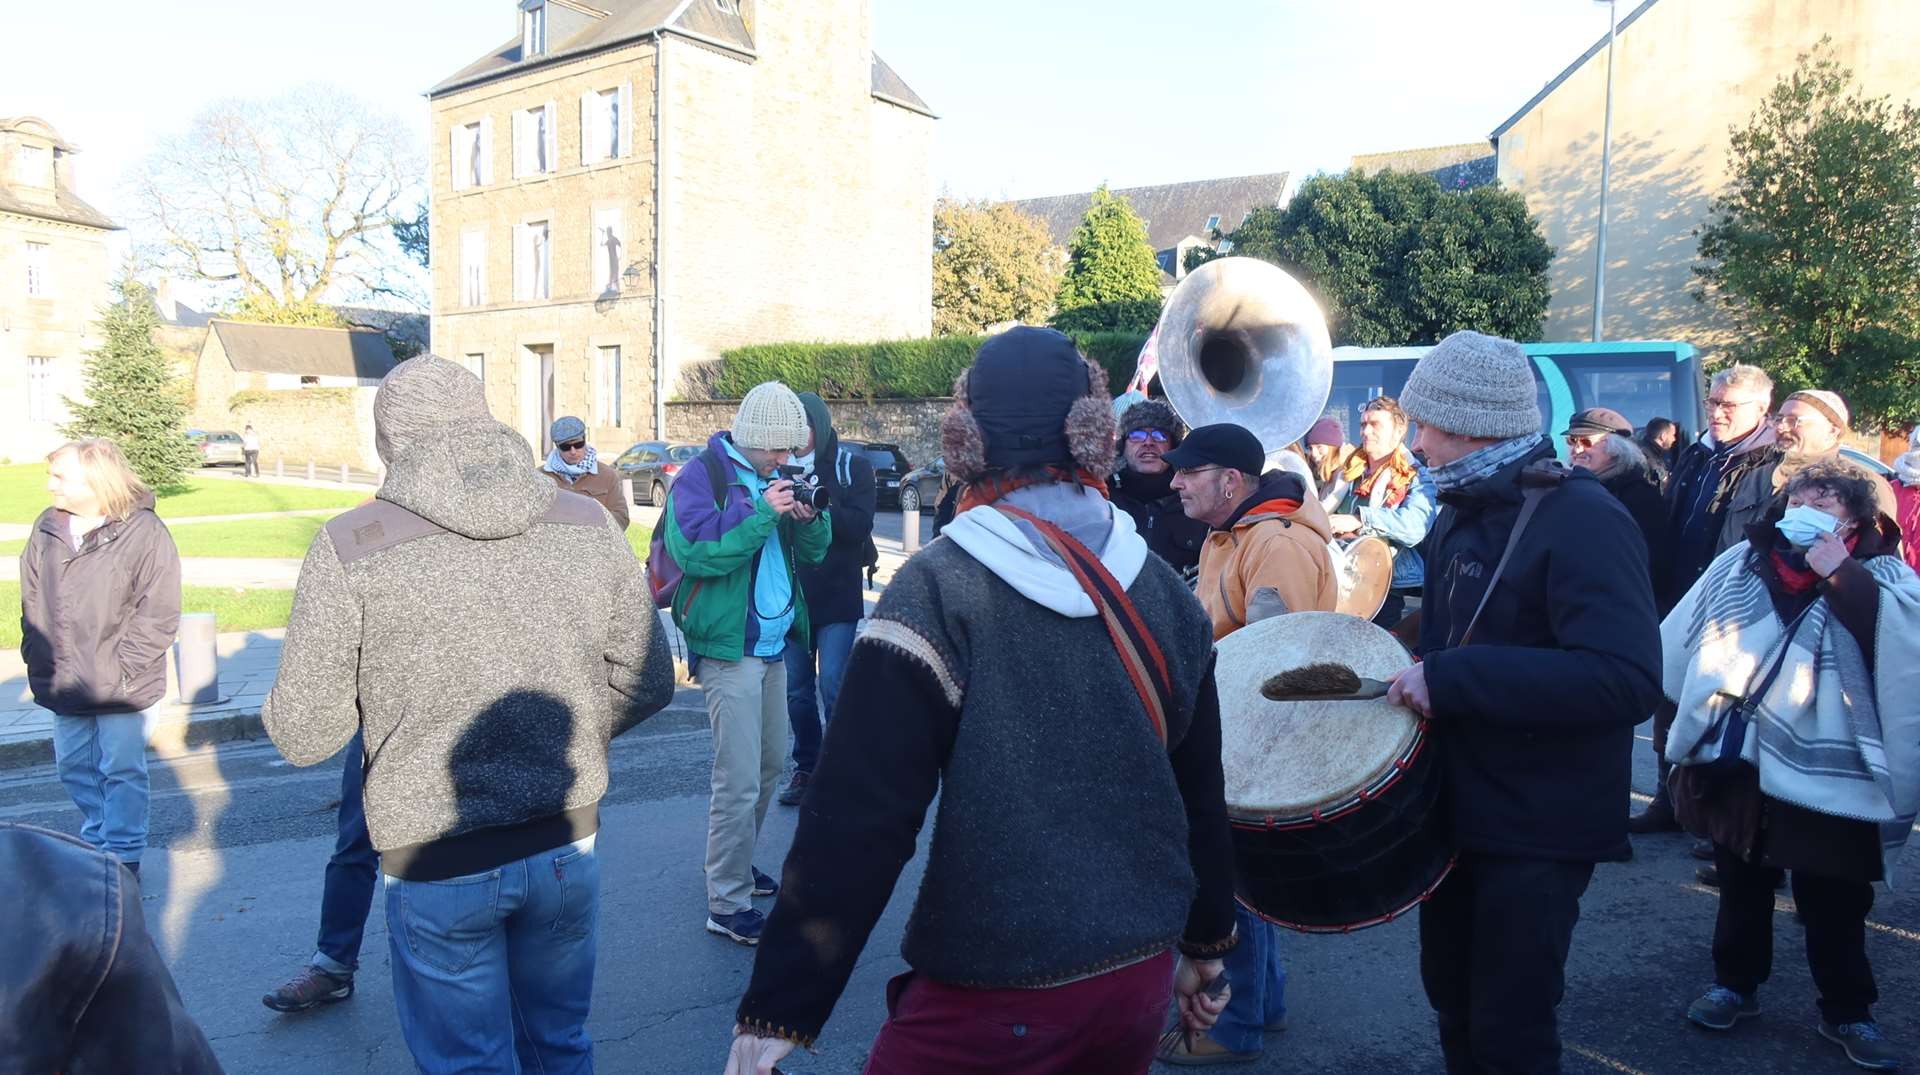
[0,691,1920,1075]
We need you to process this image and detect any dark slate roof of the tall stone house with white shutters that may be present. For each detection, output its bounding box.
[426,0,933,115]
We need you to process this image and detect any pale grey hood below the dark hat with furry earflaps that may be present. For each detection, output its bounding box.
[941,484,1146,620]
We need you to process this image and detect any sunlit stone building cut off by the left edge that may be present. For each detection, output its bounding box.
[0,115,119,463]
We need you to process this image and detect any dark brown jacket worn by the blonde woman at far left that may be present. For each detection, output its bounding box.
[19,493,180,716]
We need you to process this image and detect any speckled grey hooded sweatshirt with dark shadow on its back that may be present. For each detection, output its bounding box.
[261,355,674,879]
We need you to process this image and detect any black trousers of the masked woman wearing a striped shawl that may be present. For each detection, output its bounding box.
[1713,845,1880,1023]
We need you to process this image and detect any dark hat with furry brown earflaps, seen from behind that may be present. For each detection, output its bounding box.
[941,324,1117,482]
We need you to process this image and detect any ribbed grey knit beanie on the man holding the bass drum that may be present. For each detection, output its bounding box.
[1400,332,1540,440]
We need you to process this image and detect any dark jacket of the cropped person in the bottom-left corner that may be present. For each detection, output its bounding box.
[0,822,221,1075]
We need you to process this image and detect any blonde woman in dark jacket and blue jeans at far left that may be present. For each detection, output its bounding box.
[19,440,180,875]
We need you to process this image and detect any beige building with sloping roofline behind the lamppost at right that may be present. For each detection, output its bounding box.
[1492,0,1920,349]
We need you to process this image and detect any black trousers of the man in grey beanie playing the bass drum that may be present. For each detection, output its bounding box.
[1421,854,1594,1075]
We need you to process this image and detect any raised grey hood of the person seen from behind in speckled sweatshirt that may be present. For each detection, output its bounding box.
[372,355,559,539]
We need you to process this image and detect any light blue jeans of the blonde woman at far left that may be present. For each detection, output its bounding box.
[54,708,154,862]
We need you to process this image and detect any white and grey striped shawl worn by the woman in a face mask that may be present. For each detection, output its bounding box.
[1661,543,1920,887]
